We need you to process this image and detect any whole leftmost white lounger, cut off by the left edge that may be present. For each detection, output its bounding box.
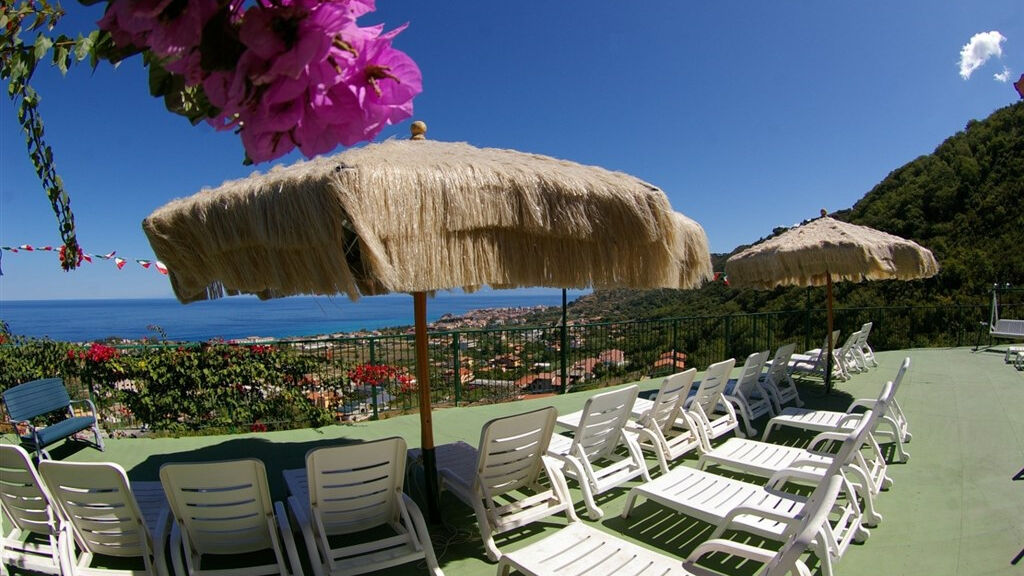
[0,444,71,574]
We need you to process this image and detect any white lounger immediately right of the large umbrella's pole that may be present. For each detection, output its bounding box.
[438,407,579,561]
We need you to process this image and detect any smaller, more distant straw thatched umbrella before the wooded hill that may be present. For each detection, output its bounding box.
[725,210,939,392]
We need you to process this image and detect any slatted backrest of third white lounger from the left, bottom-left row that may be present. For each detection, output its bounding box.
[160,458,280,554]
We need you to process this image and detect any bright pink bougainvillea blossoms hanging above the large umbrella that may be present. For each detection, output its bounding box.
[98,0,423,162]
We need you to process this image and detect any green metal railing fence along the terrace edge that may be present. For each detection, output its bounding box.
[4,305,1024,429]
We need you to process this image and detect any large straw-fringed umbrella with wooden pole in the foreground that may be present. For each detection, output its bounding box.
[142,123,711,520]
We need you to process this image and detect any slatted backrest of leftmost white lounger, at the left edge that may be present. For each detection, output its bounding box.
[0,444,56,535]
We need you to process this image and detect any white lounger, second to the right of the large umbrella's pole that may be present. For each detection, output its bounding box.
[548,385,650,520]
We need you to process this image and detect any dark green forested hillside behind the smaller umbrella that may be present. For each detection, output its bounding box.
[570,102,1024,321]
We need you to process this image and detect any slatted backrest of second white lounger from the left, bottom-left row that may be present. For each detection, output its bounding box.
[39,460,154,562]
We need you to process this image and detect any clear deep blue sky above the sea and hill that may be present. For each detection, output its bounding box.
[0,0,1024,300]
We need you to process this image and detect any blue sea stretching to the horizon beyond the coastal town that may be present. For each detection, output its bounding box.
[0,288,588,342]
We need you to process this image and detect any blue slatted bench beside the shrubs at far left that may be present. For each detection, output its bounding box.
[3,378,103,458]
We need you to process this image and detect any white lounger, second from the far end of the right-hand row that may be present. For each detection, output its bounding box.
[698,382,892,526]
